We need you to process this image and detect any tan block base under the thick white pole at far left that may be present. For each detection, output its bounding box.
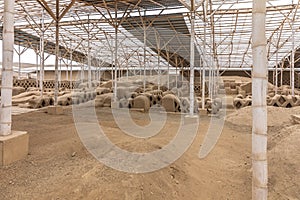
[0,131,29,166]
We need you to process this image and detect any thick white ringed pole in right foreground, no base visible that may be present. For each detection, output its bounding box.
[252,0,268,200]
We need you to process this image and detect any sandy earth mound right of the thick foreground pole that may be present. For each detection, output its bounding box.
[268,124,300,199]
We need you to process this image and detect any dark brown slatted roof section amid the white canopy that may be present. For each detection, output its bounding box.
[121,14,200,67]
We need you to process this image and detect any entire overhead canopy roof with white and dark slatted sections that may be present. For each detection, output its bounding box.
[0,0,300,72]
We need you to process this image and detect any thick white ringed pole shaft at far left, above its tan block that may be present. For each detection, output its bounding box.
[0,0,15,136]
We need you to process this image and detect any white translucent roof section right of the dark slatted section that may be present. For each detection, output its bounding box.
[192,0,300,67]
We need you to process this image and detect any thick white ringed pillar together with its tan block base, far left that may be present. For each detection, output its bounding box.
[0,0,29,166]
